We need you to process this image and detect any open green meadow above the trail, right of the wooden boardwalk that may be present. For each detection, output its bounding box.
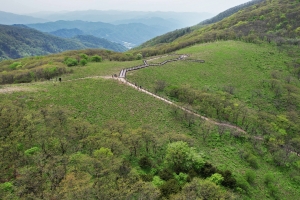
[127,41,299,110]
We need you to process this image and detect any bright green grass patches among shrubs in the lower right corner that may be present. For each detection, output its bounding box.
[198,133,300,200]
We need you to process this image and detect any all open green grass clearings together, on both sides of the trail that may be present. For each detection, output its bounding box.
[0,42,300,199]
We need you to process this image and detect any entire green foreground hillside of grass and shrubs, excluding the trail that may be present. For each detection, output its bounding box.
[0,41,300,199]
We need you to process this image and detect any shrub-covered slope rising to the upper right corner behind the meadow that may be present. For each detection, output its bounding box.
[136,0,300,55]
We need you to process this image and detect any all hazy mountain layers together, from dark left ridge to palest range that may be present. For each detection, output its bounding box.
[0,10,211,59]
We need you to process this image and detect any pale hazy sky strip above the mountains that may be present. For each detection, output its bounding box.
[0,0,250,14]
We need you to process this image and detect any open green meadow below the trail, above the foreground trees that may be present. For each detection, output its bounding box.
[2,78,186,132]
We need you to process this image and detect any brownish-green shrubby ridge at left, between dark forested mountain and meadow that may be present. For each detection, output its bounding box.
[0,49,141,85]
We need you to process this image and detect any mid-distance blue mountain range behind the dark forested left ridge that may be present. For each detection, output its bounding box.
[26,20,175,47]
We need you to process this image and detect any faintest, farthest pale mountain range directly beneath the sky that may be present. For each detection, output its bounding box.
[29,10,213,27]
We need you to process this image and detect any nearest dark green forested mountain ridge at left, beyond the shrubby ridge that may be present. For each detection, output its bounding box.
[0,25,127,60]
